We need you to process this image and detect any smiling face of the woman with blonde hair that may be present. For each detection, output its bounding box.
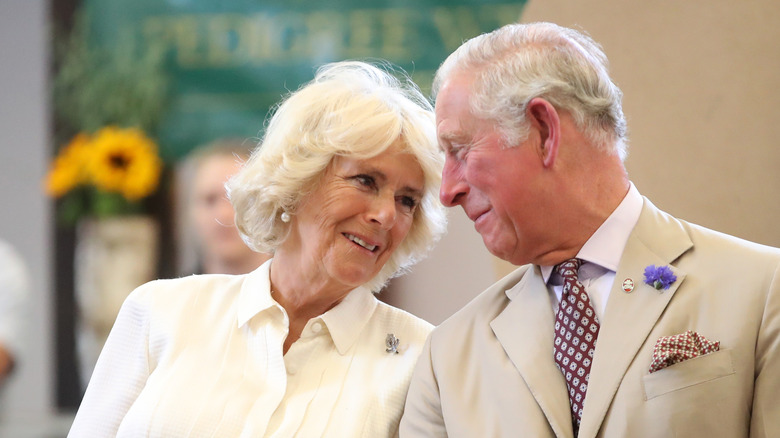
[283,143,425,289]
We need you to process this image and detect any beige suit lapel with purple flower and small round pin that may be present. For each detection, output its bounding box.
[579,198,693,437]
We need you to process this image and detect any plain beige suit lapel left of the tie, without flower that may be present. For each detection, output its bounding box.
[490,266,573,437]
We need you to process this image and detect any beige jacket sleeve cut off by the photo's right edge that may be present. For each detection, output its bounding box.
[750,258,780,438]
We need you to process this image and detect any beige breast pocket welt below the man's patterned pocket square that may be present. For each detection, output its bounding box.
[643,350,734,400]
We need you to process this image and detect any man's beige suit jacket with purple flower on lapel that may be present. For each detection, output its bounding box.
[400,199,780,438]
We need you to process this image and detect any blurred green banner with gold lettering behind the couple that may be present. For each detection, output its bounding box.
[84,0,525,161]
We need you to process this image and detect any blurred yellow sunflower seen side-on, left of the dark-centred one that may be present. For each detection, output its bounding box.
[45,133,90,198]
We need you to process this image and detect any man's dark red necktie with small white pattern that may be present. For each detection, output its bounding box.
[555,259,599,436]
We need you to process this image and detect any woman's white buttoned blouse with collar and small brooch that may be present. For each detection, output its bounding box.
[68,261,432,438]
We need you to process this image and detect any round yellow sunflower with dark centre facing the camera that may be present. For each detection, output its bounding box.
[87,126,162,201]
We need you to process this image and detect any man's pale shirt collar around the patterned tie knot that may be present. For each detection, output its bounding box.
[540,183,643,282]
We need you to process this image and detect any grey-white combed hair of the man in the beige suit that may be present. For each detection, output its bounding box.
[433,23,628,160]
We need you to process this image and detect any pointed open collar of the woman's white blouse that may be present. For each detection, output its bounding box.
[238,259,377,354]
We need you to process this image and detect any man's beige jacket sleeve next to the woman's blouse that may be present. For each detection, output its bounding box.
[399,331,447,438]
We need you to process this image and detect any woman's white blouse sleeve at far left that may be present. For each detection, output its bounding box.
[68,284,153,438]
